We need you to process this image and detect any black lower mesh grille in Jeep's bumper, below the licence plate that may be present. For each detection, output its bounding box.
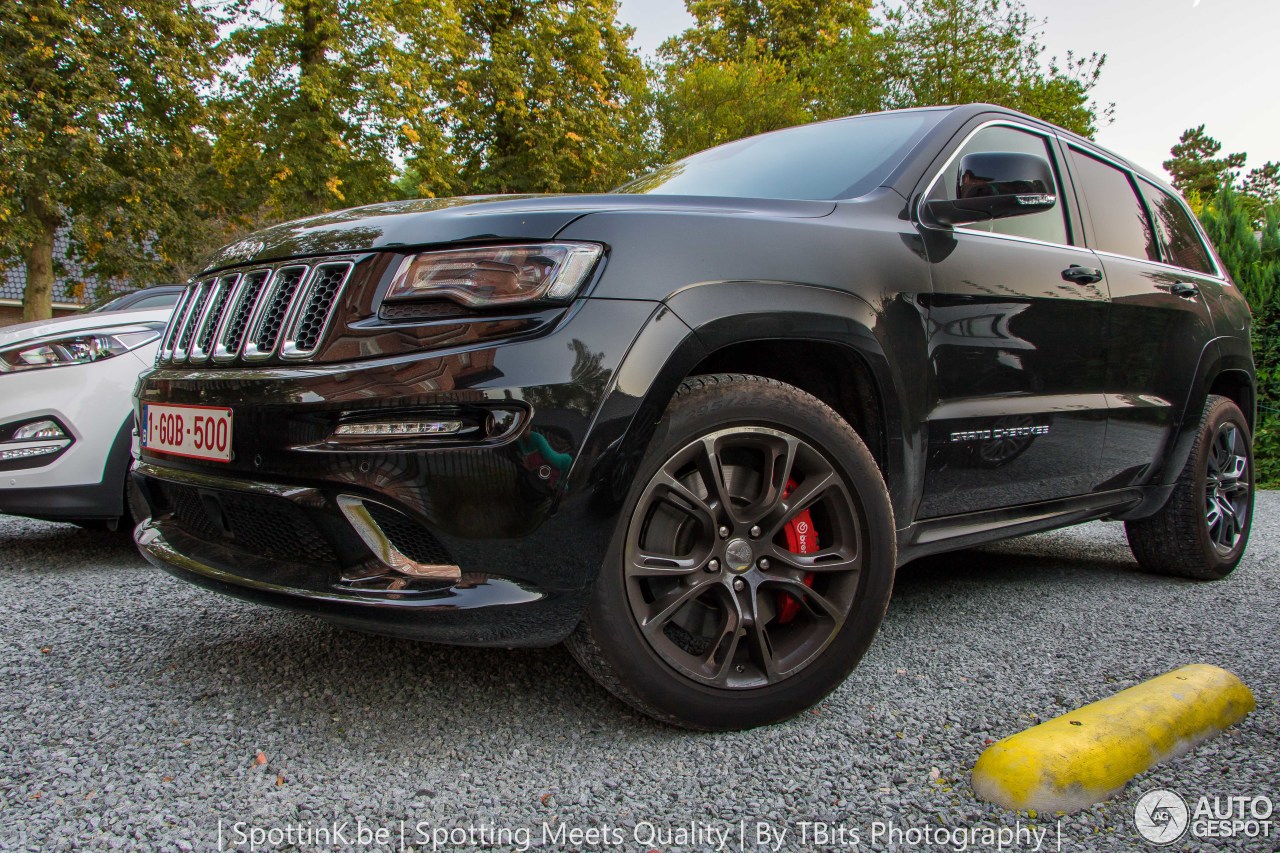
[151,480,338,564]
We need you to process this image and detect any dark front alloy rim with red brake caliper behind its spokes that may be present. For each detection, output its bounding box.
[625,427,864,689]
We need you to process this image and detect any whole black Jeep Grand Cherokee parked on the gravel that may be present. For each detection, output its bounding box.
[136,105,1254,729]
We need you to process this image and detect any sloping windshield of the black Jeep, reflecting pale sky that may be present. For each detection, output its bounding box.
[614,110,945,201]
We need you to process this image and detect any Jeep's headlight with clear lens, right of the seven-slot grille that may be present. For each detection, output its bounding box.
[385,243,603,307]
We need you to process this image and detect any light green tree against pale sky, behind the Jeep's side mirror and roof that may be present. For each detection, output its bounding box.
[883,0,1112,136]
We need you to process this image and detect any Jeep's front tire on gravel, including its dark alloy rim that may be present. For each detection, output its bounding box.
[566,374,896,730]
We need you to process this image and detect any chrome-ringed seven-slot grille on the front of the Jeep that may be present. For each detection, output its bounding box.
[157,261,352,364]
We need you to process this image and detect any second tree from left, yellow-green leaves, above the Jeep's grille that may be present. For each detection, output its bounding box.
[214,0,457,222]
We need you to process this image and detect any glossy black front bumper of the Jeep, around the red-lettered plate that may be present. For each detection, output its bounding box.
[134,300,655,646]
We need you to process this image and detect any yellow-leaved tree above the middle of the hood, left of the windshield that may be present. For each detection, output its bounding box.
[440,0,650,192]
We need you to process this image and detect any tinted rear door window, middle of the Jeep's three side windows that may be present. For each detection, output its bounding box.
[1071,149,1160,261]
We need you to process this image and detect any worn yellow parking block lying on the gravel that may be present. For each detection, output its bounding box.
[973,663,1254,812]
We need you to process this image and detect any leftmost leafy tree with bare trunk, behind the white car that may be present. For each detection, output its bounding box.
[0,0,215,320]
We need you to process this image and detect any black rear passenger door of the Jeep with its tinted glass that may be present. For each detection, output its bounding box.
[1069,146,1220,488]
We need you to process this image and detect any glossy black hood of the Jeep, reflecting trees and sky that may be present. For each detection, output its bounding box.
[205,193,836,273]
